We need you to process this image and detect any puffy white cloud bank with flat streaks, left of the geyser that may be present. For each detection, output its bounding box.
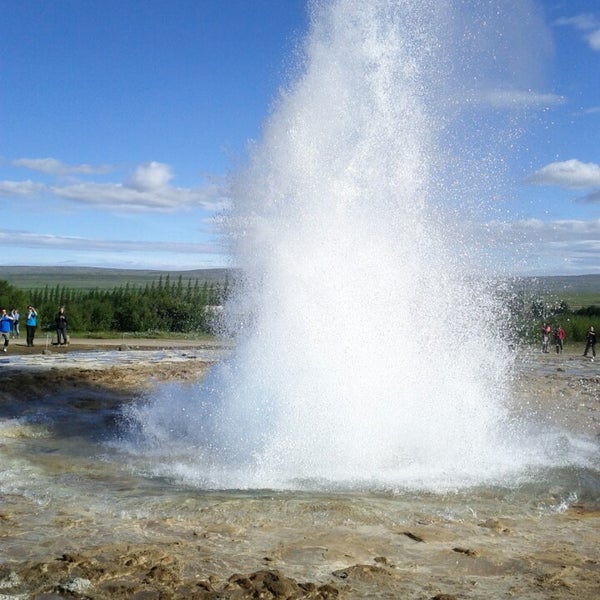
[0,159,229,213]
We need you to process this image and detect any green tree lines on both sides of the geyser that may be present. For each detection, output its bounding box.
[0,275,600,342]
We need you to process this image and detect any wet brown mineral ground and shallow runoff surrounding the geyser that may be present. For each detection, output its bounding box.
[0,347,600,600]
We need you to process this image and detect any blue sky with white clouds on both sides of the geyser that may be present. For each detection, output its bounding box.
[0,0,600,274]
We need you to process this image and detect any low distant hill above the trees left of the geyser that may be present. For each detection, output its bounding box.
[0,266,233,290]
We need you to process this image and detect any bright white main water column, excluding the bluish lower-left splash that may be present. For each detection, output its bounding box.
[218,1,505,488]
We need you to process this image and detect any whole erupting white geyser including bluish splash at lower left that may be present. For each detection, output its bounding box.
[122,0,564,489]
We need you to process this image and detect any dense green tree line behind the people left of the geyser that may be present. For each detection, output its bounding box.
[0,275,229,333]
